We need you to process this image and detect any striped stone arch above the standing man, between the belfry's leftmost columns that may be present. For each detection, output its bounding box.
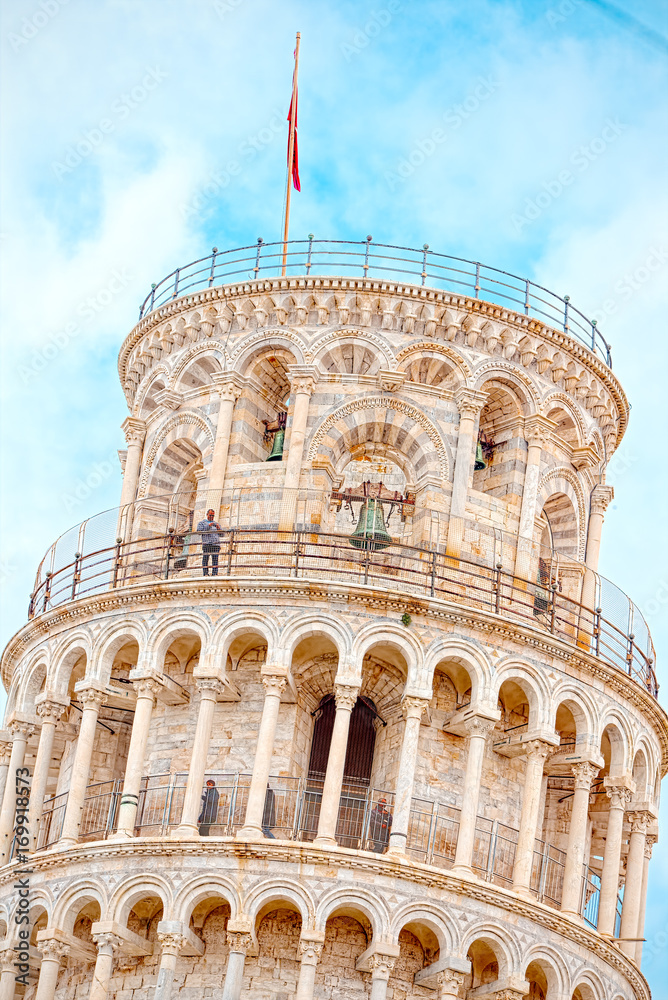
[137,410,215,499]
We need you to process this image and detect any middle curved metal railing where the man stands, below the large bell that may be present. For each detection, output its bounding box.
[28,528,658,697]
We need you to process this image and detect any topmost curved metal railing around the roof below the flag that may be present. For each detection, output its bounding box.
[134,236,612,367]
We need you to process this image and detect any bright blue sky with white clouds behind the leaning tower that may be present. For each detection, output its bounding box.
[0,0,668,984]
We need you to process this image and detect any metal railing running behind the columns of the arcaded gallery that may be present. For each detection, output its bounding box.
[37,771,621,920]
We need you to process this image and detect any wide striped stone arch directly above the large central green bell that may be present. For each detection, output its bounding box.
[307,396,451,483]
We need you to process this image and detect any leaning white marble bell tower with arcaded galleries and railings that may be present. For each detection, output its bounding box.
[0,237,668,1000]
